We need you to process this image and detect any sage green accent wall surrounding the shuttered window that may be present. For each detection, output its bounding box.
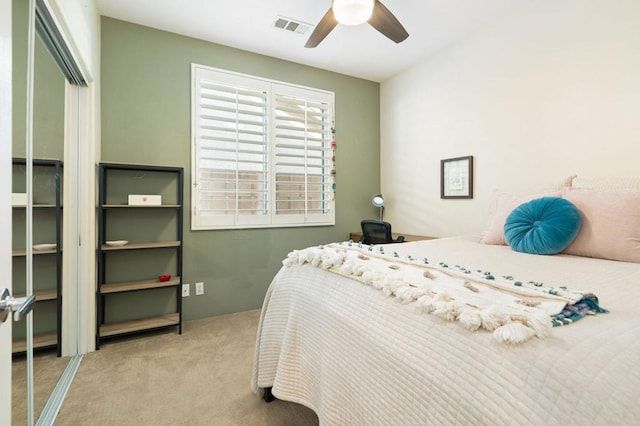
[101,17,380,320]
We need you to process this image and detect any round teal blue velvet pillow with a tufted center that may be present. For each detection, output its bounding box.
[504,197,582,254]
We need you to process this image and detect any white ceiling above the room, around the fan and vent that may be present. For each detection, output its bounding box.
[97,0,532,82]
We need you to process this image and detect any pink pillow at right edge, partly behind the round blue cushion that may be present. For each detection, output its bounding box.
[562,189,640,263]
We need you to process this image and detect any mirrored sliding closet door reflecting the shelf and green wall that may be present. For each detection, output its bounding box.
[11,0,87,425]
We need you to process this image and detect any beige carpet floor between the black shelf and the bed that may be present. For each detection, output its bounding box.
[55,310,318,426]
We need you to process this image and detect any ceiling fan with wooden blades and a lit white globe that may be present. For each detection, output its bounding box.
[304,0,409,47]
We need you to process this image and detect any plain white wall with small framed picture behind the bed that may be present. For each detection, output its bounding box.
[380,0,640,236]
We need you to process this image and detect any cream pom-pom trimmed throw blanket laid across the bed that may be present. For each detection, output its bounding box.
[282,241,607,344]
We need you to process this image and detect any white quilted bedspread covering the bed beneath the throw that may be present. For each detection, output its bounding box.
[251,237,640,425]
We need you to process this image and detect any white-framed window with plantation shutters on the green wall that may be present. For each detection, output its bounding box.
[191,64,335,229]
